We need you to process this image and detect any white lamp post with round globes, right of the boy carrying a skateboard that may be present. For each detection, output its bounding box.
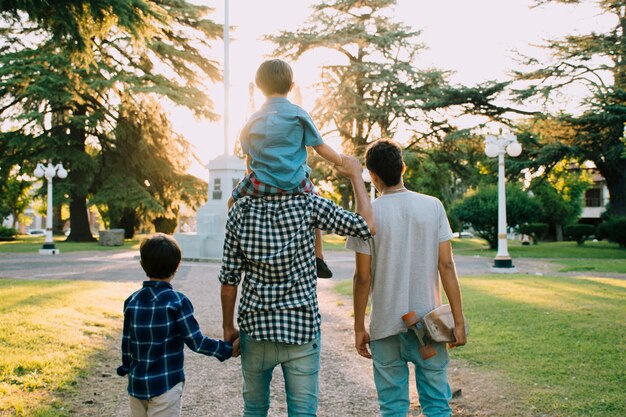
[485,135,522,272]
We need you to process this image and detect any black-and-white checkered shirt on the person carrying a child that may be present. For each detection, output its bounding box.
[219,194,371,345]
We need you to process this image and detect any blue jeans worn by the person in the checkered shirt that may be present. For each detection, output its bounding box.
[239,331,321,417]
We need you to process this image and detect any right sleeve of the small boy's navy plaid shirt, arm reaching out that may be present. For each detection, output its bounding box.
[176,296,233,362]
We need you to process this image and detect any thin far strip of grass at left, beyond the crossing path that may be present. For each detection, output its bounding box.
[0,236,141,253]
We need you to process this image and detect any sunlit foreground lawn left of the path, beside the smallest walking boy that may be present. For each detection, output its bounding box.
[0,279,136,417]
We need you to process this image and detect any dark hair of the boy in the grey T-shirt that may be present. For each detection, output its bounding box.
[365,139,404,187]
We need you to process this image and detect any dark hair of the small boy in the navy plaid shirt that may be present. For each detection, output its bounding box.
[139,233,181,279]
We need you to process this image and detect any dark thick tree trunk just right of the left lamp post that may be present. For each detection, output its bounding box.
[66,106,96,242]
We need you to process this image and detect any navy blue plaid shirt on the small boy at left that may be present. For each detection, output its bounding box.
[117,281,233,400]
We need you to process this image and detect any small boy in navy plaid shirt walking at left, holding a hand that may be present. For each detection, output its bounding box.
[117,233,239,417]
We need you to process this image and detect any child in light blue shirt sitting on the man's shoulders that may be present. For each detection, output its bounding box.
[230,59,343,278]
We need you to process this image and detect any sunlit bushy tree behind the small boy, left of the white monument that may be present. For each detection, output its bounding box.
[93,100,206,238]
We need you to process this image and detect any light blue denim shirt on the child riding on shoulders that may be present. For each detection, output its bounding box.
[239,97,324,190]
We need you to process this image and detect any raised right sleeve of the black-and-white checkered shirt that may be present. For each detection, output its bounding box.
[311,195,372,240]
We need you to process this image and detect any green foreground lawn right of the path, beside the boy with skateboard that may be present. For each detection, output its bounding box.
[336,275,626,417]
